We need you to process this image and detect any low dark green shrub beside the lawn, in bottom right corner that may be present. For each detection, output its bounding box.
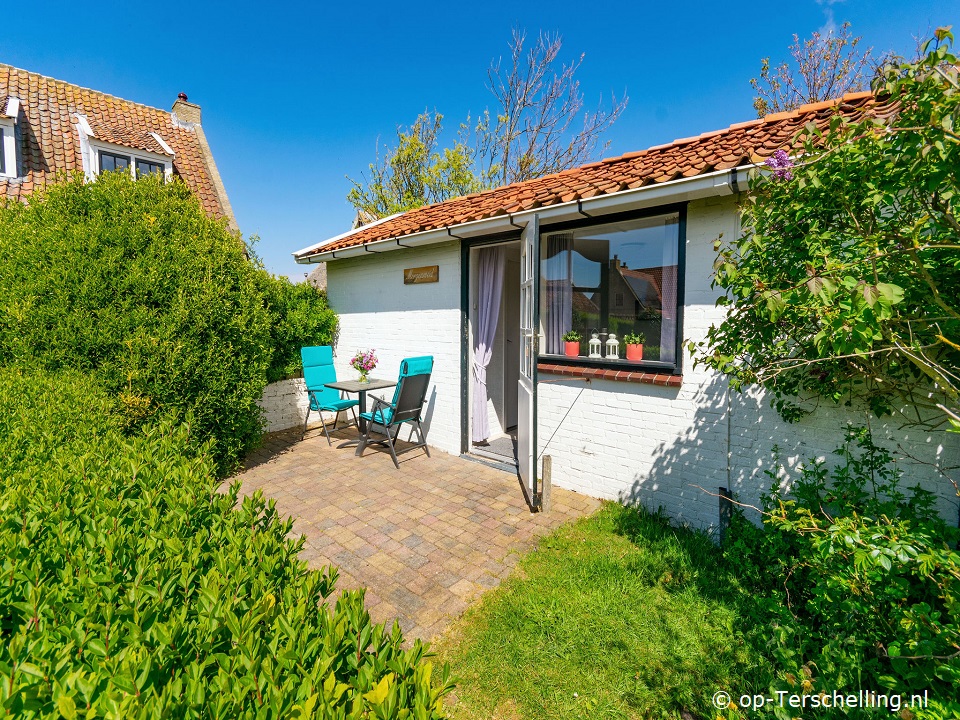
[727,428,960,716]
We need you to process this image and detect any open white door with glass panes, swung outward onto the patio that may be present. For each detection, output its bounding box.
[517,215,540,509]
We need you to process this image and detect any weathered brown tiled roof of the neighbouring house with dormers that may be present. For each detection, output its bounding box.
[0,64,236,227]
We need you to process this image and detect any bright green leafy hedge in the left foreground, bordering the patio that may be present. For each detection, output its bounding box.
[0,370,449,720]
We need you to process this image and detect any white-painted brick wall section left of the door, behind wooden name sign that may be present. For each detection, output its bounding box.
[327,242,460,454]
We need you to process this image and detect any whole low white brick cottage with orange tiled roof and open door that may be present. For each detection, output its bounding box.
[295,94,960,528]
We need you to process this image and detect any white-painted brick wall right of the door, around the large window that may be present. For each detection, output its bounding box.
[538,199,960,528]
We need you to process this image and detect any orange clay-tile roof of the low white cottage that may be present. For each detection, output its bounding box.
[295,92,893,260]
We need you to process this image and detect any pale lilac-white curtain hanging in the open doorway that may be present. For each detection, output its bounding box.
[473,247,505,442]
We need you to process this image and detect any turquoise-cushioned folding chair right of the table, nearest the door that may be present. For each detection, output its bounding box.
[357,355,433,468]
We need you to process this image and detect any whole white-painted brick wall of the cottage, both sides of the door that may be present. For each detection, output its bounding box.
[328,198,960,528]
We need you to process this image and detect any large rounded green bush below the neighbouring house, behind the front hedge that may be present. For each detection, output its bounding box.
[0,173,326,472]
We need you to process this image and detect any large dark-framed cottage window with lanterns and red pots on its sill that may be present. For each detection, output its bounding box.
[540,212,680,367]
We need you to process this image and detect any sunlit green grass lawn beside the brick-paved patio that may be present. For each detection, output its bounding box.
[437,503,764,720]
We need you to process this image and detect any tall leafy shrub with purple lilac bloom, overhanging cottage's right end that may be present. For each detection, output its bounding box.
[689,35,960,424]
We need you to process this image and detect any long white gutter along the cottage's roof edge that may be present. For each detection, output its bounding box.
[293,165,756,265]
